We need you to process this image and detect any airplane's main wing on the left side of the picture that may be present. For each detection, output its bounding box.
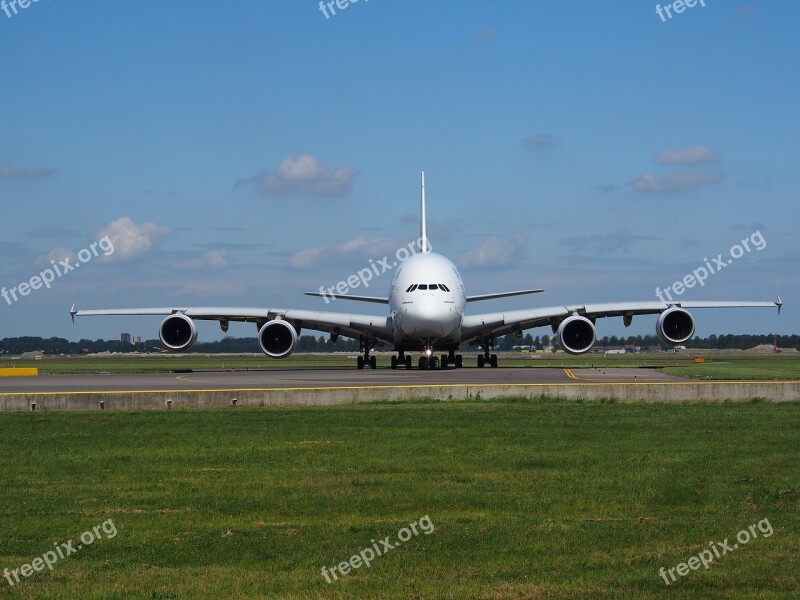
[70,306,394,343]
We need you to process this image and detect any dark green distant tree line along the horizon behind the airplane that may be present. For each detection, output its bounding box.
[0,334,800,355]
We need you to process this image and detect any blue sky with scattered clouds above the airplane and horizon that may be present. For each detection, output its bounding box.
[0,0,800,339]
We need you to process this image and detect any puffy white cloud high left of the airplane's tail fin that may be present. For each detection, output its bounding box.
[236,154,356,196]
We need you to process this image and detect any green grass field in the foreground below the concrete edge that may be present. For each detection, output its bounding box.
[0,401,800,599]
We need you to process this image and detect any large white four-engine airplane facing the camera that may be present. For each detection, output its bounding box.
[70,172,783,369]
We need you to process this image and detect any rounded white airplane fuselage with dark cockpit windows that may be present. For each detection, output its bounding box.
[389,252,466,350]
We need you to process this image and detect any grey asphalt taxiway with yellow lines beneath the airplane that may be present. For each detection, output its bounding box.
[0,367,683,395]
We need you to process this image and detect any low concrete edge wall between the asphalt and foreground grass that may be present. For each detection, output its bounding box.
[0,381,800,411]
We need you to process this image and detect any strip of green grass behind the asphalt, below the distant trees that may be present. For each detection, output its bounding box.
[6,352,800,380]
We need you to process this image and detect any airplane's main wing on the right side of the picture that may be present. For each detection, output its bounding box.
[461,297,783,342]
